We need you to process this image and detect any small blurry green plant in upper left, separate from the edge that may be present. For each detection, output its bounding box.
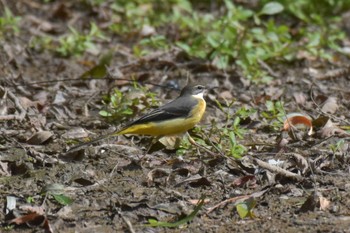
[56,23,106,56]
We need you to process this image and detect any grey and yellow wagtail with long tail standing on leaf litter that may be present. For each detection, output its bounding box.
[68,85,206,152]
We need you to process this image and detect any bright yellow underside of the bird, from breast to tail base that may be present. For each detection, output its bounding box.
[117,99,206,136]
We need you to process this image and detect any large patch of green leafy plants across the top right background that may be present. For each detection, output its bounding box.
[112,0,350,82]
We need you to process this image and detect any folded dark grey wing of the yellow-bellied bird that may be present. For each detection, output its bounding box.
[126,97,198,127]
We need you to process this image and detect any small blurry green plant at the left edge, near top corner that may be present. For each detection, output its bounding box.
[0,7,21,36]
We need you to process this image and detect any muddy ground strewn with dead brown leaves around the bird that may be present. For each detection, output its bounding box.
[0,1,350,232]
